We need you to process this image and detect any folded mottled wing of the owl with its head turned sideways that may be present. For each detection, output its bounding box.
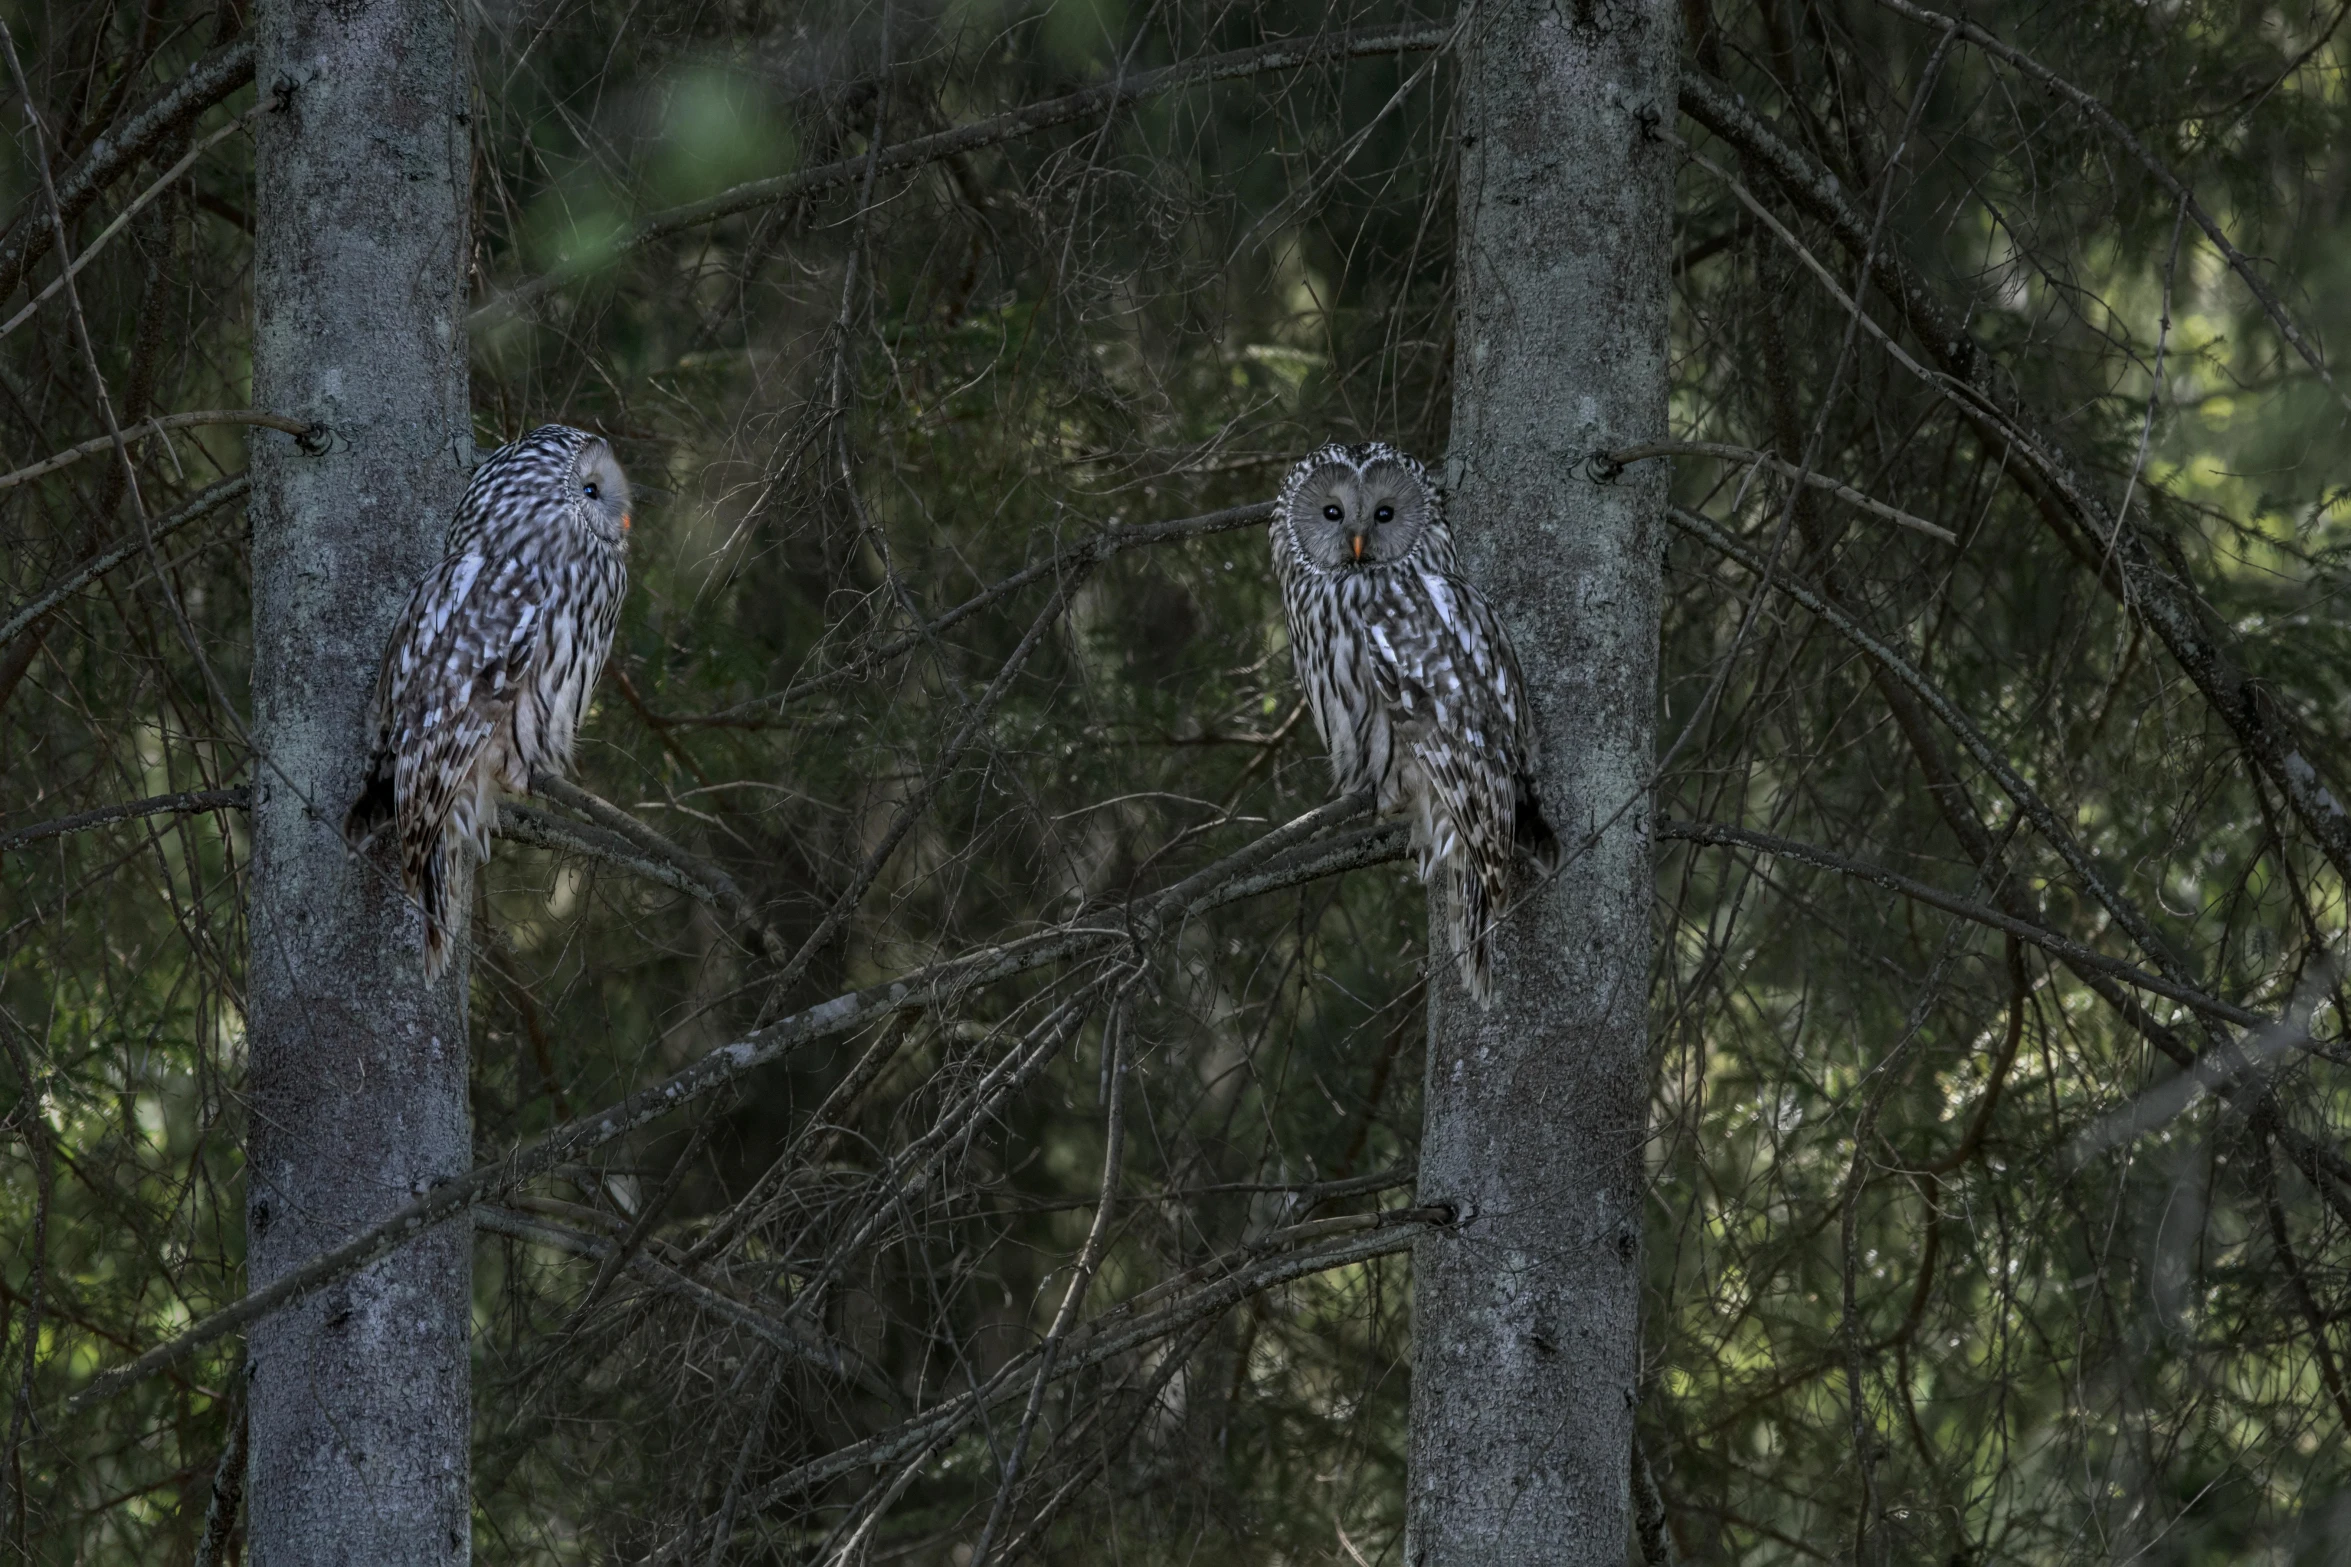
[381,550,545,862]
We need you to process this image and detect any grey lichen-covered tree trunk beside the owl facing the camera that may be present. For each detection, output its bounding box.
[1408,0,1676,1567]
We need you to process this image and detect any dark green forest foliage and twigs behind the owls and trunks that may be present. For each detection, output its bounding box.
[0,0,2351,1565]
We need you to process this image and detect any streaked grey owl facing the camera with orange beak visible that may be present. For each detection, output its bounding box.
[1270,442,1559,1006]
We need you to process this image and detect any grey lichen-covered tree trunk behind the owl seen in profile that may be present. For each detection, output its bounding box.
[247,0,473,1567]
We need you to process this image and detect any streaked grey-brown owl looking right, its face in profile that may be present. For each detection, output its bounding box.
[343,425,630,980]
